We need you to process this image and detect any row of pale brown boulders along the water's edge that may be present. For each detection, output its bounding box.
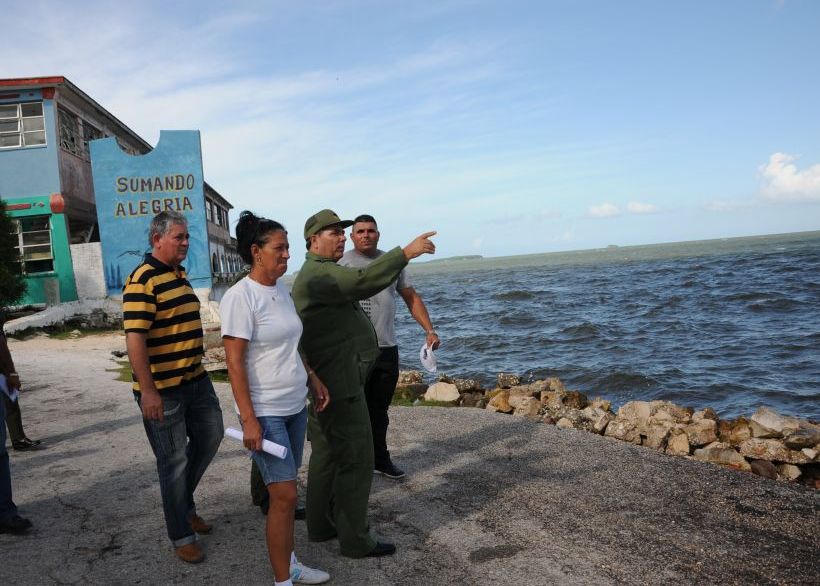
[396,371,820,488]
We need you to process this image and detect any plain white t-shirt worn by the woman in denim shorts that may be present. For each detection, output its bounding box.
[219,277,307,417]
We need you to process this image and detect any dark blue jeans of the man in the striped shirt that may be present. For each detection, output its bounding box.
[137,376,223,547]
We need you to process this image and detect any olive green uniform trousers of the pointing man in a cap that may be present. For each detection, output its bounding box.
[306,390,376,558]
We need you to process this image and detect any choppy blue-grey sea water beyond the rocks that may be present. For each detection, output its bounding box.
[397,232,820,419]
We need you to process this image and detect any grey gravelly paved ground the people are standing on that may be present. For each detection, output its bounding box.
[0,334,820,586]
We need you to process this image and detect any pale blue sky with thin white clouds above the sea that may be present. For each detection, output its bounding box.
[6,0,820,268]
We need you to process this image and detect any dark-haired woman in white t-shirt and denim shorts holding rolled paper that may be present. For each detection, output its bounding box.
[220,211,330,585]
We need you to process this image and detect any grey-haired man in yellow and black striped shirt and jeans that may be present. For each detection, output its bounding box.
[122,211,223,563]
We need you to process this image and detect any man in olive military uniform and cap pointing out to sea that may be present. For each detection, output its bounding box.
[293,210,435,558]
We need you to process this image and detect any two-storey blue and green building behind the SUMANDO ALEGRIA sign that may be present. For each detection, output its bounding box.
[0,76,239,305]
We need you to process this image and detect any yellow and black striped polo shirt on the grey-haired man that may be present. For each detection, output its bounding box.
[122,254,206,393]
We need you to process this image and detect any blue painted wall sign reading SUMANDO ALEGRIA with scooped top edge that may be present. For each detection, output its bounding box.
[90,130,211,295]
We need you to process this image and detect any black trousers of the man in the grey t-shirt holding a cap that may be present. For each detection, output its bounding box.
[364,346,399,466]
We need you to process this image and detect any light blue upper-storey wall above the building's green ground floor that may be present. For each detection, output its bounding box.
[0,90,60,200]
